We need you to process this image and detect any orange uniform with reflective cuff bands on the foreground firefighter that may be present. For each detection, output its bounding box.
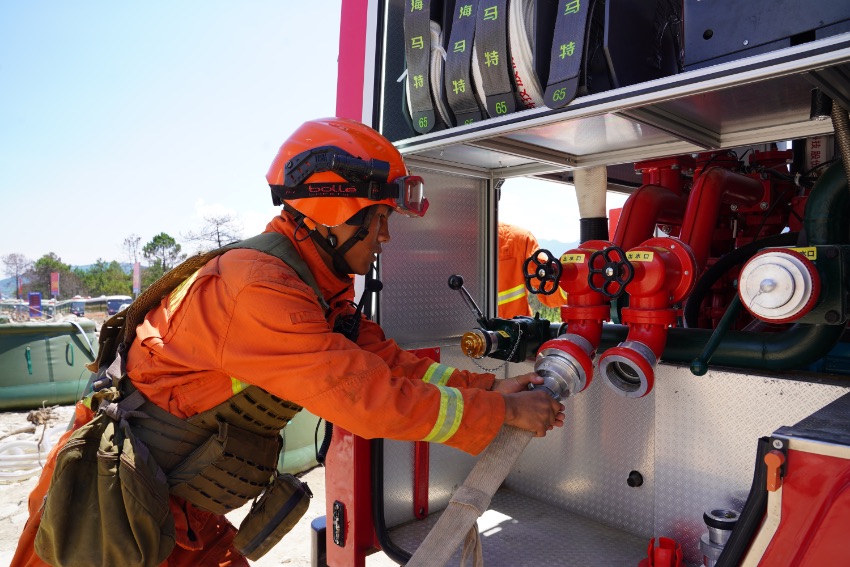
[13,213,505,567]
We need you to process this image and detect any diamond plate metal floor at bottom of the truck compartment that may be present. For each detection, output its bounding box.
[366,489,648,567]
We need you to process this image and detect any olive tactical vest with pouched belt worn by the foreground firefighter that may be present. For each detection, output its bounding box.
[89,232,327,514]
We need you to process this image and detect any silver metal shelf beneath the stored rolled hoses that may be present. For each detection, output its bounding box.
[396,33,850,178]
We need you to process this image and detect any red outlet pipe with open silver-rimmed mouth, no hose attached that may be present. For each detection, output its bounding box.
[599,237,696,398]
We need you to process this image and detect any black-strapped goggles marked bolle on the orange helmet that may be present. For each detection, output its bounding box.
[271,146,428,217]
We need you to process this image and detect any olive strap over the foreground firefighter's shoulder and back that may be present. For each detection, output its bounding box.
[86,232,328,372]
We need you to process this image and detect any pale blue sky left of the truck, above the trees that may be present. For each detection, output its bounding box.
[0,0,340,265]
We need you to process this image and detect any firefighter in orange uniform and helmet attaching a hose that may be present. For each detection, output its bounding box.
[12,118,564,567]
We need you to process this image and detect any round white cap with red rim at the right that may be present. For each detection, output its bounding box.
[738,248,820,323]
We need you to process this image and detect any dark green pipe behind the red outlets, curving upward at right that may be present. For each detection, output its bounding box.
[599,161,850,370]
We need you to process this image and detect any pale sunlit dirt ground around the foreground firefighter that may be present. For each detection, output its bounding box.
[0,406,395,567]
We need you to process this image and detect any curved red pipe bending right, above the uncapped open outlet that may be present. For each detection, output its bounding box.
[679,167,764,270]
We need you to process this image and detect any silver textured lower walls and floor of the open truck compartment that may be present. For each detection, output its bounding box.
[372,347,850,567]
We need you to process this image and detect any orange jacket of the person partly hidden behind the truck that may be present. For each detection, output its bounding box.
[498,222,566,319]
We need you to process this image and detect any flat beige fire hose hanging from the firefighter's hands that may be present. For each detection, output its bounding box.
[407,425,532,567]
